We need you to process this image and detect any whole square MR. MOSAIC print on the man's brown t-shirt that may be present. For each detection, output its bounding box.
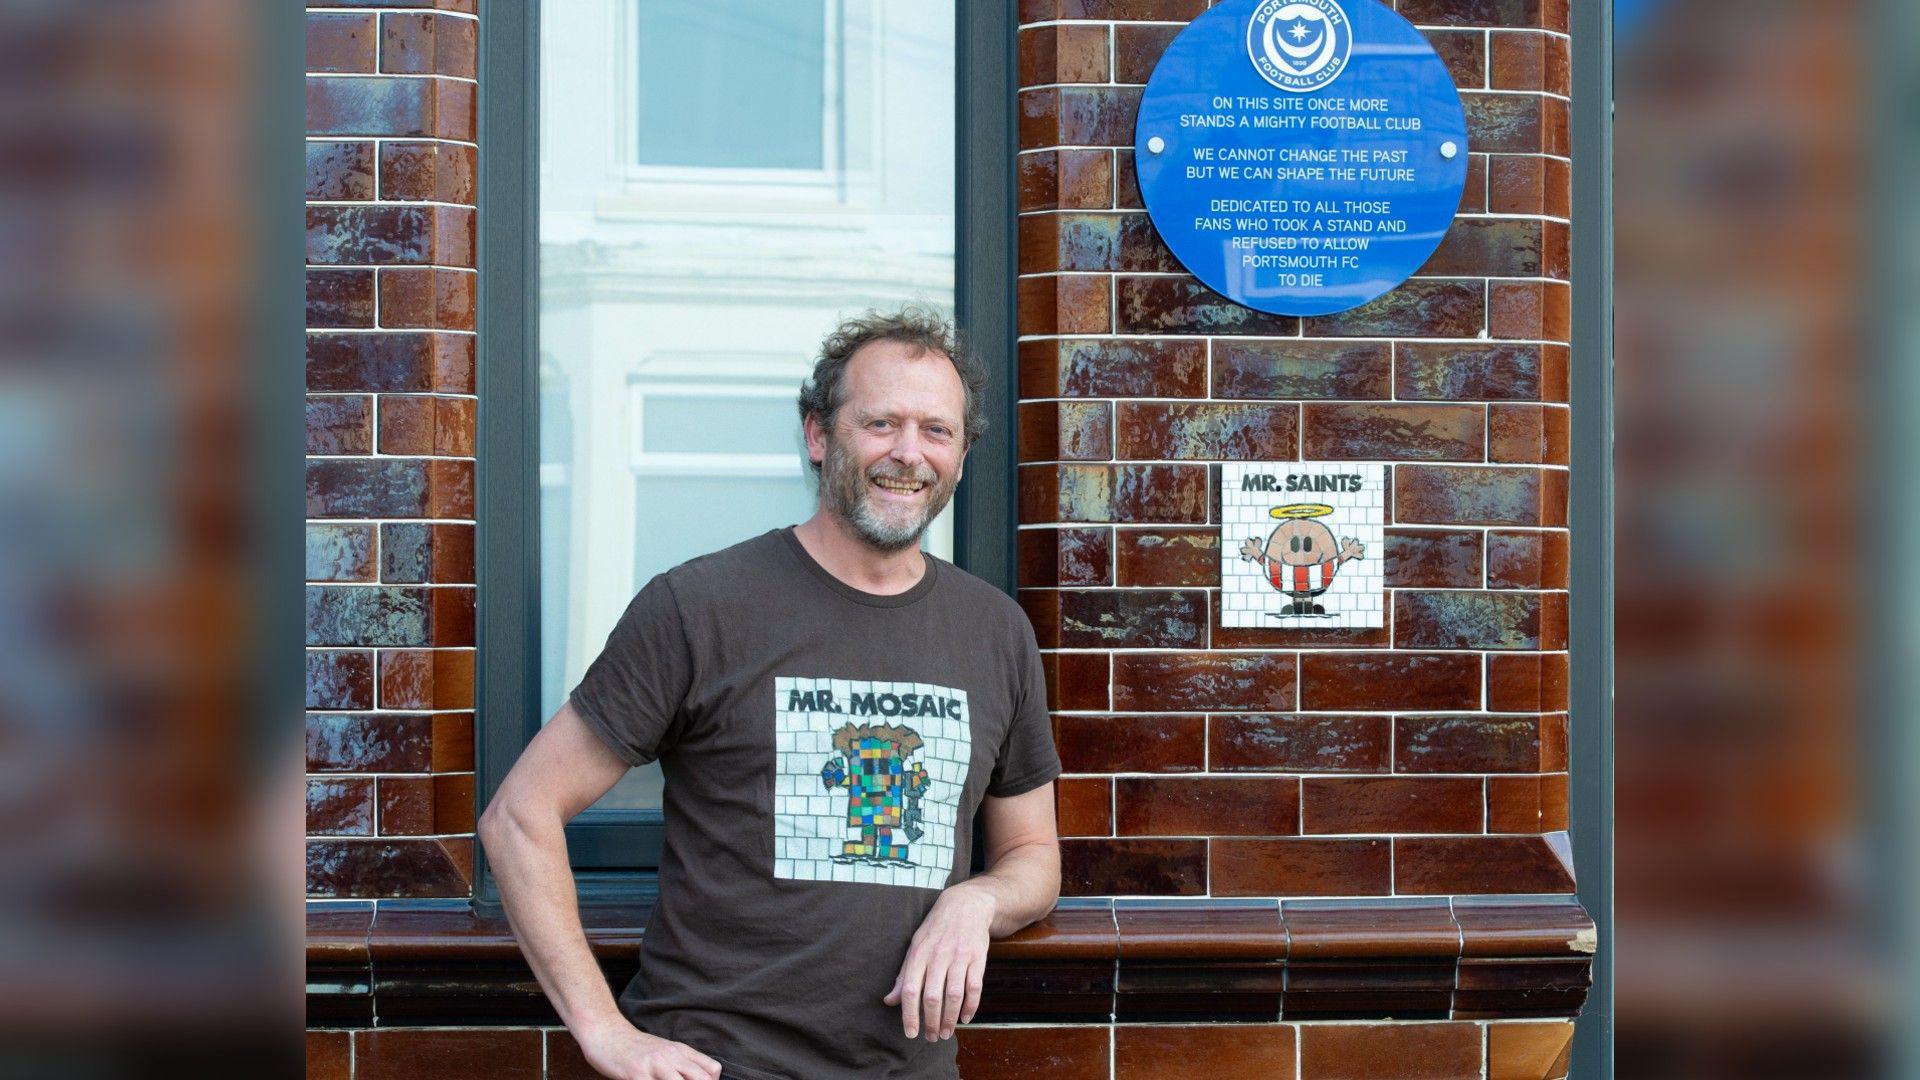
[774,675,973,888]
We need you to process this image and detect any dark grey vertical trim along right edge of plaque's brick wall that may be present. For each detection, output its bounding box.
[1569,4,1613,1080]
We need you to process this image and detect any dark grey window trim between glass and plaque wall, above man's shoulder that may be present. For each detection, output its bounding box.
[954,2,1020,595]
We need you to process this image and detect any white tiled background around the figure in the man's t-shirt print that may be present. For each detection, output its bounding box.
[774,675,973,890]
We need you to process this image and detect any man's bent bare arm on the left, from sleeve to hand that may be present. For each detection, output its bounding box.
[480,703,720,1080]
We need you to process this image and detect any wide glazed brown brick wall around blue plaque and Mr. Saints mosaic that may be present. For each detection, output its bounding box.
[1018,0,1572,891]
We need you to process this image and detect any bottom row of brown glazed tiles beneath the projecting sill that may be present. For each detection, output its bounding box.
[307,1020,1572,1080]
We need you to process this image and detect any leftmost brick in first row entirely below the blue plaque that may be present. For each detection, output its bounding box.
[1020,336,1206,398]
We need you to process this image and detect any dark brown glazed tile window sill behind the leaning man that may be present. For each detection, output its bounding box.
[307,896,1594,1026]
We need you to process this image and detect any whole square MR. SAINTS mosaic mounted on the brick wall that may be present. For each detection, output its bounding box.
[1219,461,1386,630]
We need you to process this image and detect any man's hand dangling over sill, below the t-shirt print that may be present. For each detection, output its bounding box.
[883,882,996,1042]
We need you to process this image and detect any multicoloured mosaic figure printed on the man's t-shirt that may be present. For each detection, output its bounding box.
[820,724,933,867]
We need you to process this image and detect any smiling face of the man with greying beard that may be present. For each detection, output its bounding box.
[806,342,966,552]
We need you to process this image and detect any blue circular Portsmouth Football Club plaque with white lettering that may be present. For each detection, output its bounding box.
[1133,0,1467,315]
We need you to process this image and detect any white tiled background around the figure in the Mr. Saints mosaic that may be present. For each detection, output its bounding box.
[1219,461,1386,630]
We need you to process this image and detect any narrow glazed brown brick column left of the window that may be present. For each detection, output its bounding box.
[305,0,478,895]
